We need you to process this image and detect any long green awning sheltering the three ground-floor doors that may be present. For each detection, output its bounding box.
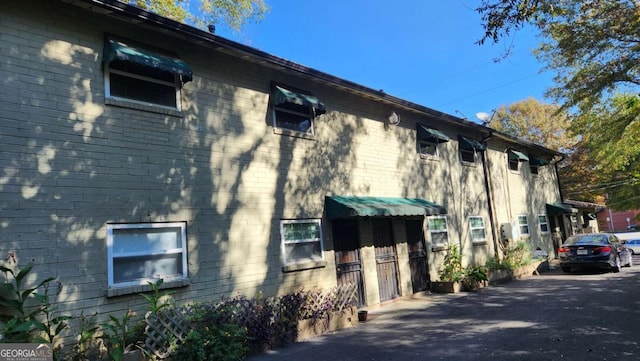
[325,196,447,219]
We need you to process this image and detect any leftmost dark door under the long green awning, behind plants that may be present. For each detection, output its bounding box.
[332,219,365,306]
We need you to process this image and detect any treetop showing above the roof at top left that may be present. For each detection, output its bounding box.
[119,0,269,30]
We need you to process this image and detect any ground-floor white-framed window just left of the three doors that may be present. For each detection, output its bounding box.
[280,219,324,267]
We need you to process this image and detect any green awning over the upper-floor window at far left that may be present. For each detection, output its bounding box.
[103,39,193,83]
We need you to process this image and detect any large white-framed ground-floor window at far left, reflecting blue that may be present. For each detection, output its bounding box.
[107,222,187,288]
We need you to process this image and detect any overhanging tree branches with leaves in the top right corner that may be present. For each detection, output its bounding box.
[477,0,640,112]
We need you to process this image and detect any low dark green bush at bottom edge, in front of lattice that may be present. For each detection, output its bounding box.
[174,324,248,361]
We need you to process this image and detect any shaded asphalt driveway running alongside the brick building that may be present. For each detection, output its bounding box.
[250,265,640,361]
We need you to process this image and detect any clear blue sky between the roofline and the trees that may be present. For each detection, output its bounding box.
[217,0,553,121]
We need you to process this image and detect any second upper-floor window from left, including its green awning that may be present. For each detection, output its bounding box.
[271,85,326,136]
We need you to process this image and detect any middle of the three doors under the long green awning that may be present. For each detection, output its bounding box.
[373,219,400,302]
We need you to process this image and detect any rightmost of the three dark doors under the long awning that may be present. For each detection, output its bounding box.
[406,220,429,293]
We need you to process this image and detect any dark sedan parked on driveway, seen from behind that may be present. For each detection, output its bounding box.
[558,233,623,272]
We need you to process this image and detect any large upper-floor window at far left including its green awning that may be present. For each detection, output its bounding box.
[103,38,193,110]
